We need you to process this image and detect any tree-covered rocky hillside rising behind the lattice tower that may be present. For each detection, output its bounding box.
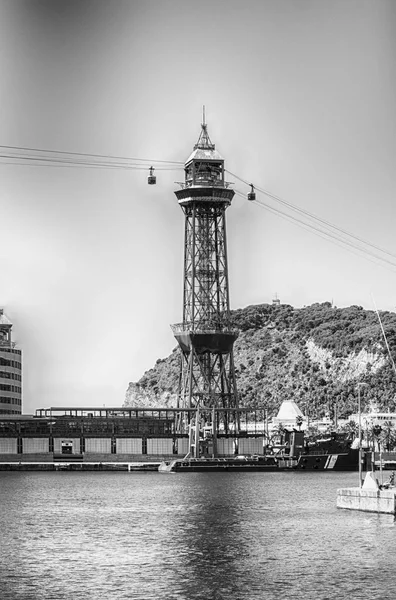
[125,302,396,417]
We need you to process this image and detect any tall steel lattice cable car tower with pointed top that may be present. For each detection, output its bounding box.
[172,119,238,429]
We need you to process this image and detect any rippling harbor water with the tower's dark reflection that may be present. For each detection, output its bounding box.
[0,471,396,600]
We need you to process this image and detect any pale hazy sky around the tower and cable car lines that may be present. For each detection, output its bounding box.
[0,0,396,413]
